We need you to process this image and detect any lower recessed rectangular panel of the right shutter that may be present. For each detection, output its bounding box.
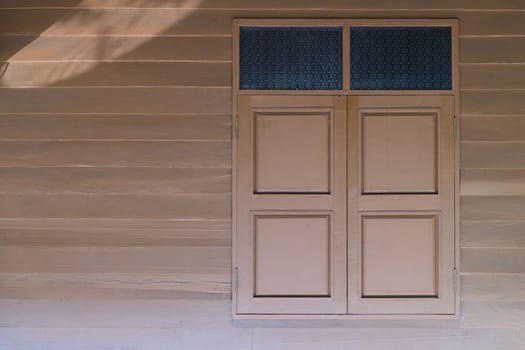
[361,215,438,297]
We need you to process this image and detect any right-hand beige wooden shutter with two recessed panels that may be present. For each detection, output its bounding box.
[348,95,454,314]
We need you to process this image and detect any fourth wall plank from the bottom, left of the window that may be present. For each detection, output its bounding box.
[0,246,231,277]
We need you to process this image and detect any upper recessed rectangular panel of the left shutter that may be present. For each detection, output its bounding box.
[253,112,331,193]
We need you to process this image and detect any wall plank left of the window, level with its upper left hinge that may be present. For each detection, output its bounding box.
[0,114,232,141]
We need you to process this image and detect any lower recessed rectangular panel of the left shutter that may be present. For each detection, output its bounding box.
[253,214,331,297]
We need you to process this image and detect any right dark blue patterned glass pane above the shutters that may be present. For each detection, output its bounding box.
[350,27,452,90]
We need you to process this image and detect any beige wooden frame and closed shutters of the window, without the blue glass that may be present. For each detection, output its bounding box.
[233,20,458,319]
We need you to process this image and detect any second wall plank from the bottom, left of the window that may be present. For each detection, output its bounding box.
[0,299,231,329]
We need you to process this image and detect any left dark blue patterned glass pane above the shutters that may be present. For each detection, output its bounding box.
[239,27,343,90]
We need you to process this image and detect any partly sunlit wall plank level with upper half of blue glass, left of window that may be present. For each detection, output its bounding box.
[0,35,231,62]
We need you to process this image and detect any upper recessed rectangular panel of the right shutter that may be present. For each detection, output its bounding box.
[361,111,438,194]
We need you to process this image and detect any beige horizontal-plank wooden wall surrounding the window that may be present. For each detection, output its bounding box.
[0,0,525,350]
